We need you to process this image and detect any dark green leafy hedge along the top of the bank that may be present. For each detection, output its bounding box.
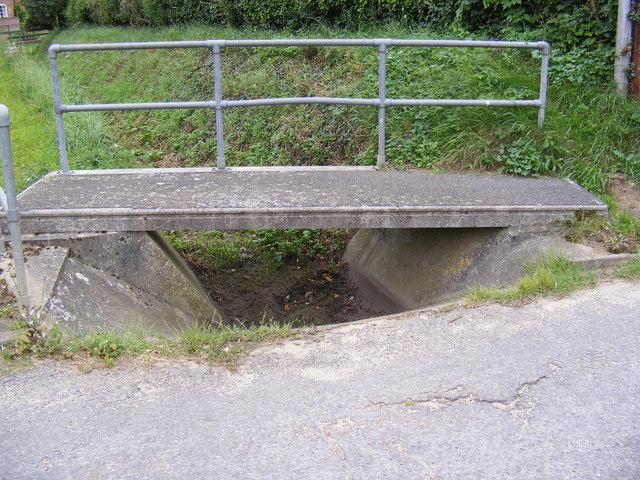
[21,0,617,55]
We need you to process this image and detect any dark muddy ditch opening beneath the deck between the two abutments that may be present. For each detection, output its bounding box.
[167,229,380,326]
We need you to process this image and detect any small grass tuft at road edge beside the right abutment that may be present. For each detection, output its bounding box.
[467,255,597,303]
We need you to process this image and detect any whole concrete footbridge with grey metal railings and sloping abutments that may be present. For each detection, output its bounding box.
[0,38,607,327]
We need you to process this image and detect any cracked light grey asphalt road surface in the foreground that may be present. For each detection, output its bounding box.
[0,281,640,480]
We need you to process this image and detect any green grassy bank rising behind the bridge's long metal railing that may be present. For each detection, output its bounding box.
[3,25,640,193]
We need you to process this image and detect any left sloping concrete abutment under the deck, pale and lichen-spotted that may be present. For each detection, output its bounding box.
[2,232,226,334]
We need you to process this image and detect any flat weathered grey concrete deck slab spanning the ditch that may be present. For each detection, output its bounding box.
[3,167,606,233]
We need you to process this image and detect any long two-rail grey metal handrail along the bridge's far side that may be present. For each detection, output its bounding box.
[49,38,550,173]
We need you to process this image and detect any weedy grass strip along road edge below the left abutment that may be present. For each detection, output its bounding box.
[2,318,297,367]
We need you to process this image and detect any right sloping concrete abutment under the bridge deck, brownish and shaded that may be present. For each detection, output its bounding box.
[345,225,596,313]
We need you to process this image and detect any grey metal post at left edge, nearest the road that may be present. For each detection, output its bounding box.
[0,105,29,310]
